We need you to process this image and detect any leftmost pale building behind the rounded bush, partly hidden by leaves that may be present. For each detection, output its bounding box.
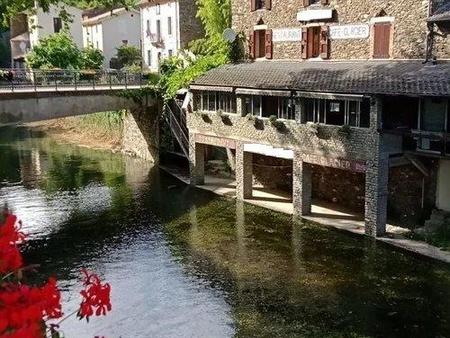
[10,5,83,67]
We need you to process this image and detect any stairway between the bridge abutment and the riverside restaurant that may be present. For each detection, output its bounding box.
[164,100,189,158]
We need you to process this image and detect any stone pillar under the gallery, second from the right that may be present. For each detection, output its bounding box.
[292,152,312,216]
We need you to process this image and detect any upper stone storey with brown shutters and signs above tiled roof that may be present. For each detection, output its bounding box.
[232,0,450,60]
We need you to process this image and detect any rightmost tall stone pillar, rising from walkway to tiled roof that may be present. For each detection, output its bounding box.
[365,97,389,237]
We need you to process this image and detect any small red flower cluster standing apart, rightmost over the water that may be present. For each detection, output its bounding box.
[78,269,112,320]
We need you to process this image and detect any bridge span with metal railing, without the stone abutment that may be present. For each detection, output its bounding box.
[0,70,144,124]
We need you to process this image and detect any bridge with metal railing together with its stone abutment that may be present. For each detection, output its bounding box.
[0,70,162,162]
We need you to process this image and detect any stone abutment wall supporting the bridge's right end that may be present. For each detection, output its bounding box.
[122,99,161,163]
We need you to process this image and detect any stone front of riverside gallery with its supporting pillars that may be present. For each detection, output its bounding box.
[187,93,402,236]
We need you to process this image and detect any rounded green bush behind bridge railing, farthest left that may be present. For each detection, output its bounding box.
[26,32,83,69]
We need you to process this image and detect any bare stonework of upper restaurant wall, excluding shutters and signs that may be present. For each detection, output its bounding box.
[232,0,450,60]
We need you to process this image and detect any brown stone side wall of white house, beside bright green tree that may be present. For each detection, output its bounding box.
[178,0,205,49]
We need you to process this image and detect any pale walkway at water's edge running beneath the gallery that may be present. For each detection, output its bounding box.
[160,166,450,264]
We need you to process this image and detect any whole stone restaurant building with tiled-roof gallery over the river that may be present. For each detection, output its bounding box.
[187,0,450,236]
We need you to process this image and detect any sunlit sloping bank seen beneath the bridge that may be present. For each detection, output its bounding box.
[25,112,123,153]
